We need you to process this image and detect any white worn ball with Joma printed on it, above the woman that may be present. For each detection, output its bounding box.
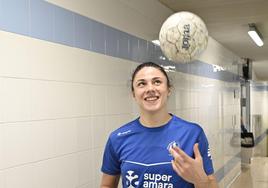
[159,11,208,63]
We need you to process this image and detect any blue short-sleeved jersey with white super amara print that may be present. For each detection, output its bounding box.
[102,115,213,188]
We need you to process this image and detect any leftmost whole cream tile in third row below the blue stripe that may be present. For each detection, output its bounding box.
[2,121,56,168]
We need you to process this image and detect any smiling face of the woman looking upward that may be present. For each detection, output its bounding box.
[132,67,170,114]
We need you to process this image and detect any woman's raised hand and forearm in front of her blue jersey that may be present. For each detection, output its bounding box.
[170,144,218,188]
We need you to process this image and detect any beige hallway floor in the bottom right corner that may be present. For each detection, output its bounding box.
[230,157,268,188]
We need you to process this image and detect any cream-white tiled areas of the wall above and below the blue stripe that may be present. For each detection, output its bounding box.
[0,0,246,188]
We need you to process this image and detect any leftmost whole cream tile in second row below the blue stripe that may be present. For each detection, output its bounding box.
[31,81,91,119]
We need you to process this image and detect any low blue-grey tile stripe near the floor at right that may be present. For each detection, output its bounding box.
[215,129,268,182]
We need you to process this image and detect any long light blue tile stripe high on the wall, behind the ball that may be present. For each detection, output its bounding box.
[0,0,239,82]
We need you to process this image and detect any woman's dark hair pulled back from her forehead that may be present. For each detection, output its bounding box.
[131,62,171,92]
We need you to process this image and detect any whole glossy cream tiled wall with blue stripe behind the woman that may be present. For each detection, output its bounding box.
[0,0,247,188]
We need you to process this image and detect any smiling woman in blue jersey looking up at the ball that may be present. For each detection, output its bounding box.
[101,62,217,188]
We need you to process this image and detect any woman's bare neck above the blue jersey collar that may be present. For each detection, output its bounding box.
[140,112,171,127]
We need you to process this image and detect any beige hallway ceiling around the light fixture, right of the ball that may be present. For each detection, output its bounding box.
[159,0,268,81]
